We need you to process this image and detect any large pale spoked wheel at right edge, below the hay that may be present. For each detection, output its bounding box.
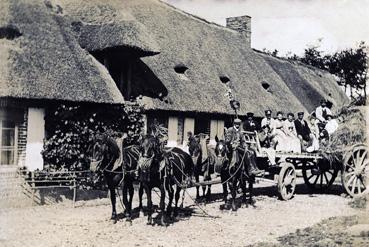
[341,144,369,197]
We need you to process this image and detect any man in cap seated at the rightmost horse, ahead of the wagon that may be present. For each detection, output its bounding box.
[225,118,263,176]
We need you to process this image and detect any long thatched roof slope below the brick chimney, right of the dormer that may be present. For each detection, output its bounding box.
[122,0,348,116]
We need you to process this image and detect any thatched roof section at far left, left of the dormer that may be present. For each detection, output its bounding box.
[0,0,124,103]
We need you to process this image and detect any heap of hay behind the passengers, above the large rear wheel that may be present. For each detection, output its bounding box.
[321,107,367,161]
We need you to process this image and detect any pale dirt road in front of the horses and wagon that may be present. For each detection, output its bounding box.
[0,181,358,246]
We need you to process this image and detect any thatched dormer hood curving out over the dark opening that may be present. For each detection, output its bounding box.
[52,0,159,56]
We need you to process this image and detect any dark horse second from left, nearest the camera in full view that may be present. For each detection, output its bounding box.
[138,135,193,225]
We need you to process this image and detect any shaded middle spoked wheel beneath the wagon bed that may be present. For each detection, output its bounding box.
[302,160,338,191]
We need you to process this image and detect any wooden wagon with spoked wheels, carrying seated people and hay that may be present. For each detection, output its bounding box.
[244,132,369,200]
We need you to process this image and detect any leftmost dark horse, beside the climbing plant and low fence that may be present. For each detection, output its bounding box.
[90,134,139,223]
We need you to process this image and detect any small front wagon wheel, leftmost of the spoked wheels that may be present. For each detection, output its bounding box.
[278,162,296,201]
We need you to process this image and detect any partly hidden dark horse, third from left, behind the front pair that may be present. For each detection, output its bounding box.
[188,134,214,199]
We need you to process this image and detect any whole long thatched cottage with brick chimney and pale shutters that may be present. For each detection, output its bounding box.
[0,0,348,171]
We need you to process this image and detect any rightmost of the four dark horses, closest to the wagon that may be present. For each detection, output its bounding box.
[211,137,255,211]
